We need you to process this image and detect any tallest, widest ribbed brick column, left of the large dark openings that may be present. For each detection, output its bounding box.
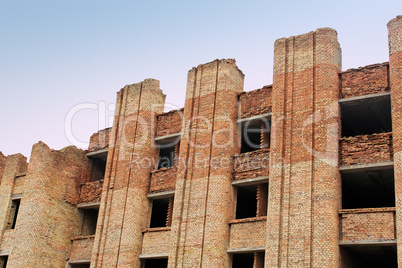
[265,28,341,267]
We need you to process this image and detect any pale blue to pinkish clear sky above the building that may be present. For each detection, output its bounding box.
[0,0,402,158]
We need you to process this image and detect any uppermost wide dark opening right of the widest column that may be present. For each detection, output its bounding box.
[339,95,392,137]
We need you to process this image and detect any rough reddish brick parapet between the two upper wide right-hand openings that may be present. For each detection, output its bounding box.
[339,132,393,166]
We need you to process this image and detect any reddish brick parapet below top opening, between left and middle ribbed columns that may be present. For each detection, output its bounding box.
[149,166,177,193]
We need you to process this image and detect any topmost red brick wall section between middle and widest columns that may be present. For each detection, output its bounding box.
[239,85,272,118]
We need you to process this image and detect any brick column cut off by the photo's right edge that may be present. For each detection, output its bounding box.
[387,16,402,266]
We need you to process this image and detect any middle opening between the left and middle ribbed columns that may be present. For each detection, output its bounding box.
[150,197,173,228]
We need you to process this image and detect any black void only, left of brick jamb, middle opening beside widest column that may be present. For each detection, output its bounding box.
[236,185,257,219]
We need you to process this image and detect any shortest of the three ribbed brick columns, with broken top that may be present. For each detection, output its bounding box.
[91,79,165,267]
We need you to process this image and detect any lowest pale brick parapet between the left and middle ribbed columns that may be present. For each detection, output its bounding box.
[141,227,170,255]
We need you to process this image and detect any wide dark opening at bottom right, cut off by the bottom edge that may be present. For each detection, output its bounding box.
[341,244,398,268]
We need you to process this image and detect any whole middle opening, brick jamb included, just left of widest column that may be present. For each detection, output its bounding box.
[236,183,268,219]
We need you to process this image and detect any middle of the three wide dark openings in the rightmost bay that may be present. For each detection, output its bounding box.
[341,168,395,209]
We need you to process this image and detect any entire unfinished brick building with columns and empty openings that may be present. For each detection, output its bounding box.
[0,16,402,268]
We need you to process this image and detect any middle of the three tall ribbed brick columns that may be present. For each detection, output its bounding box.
[169,60,244,268]
